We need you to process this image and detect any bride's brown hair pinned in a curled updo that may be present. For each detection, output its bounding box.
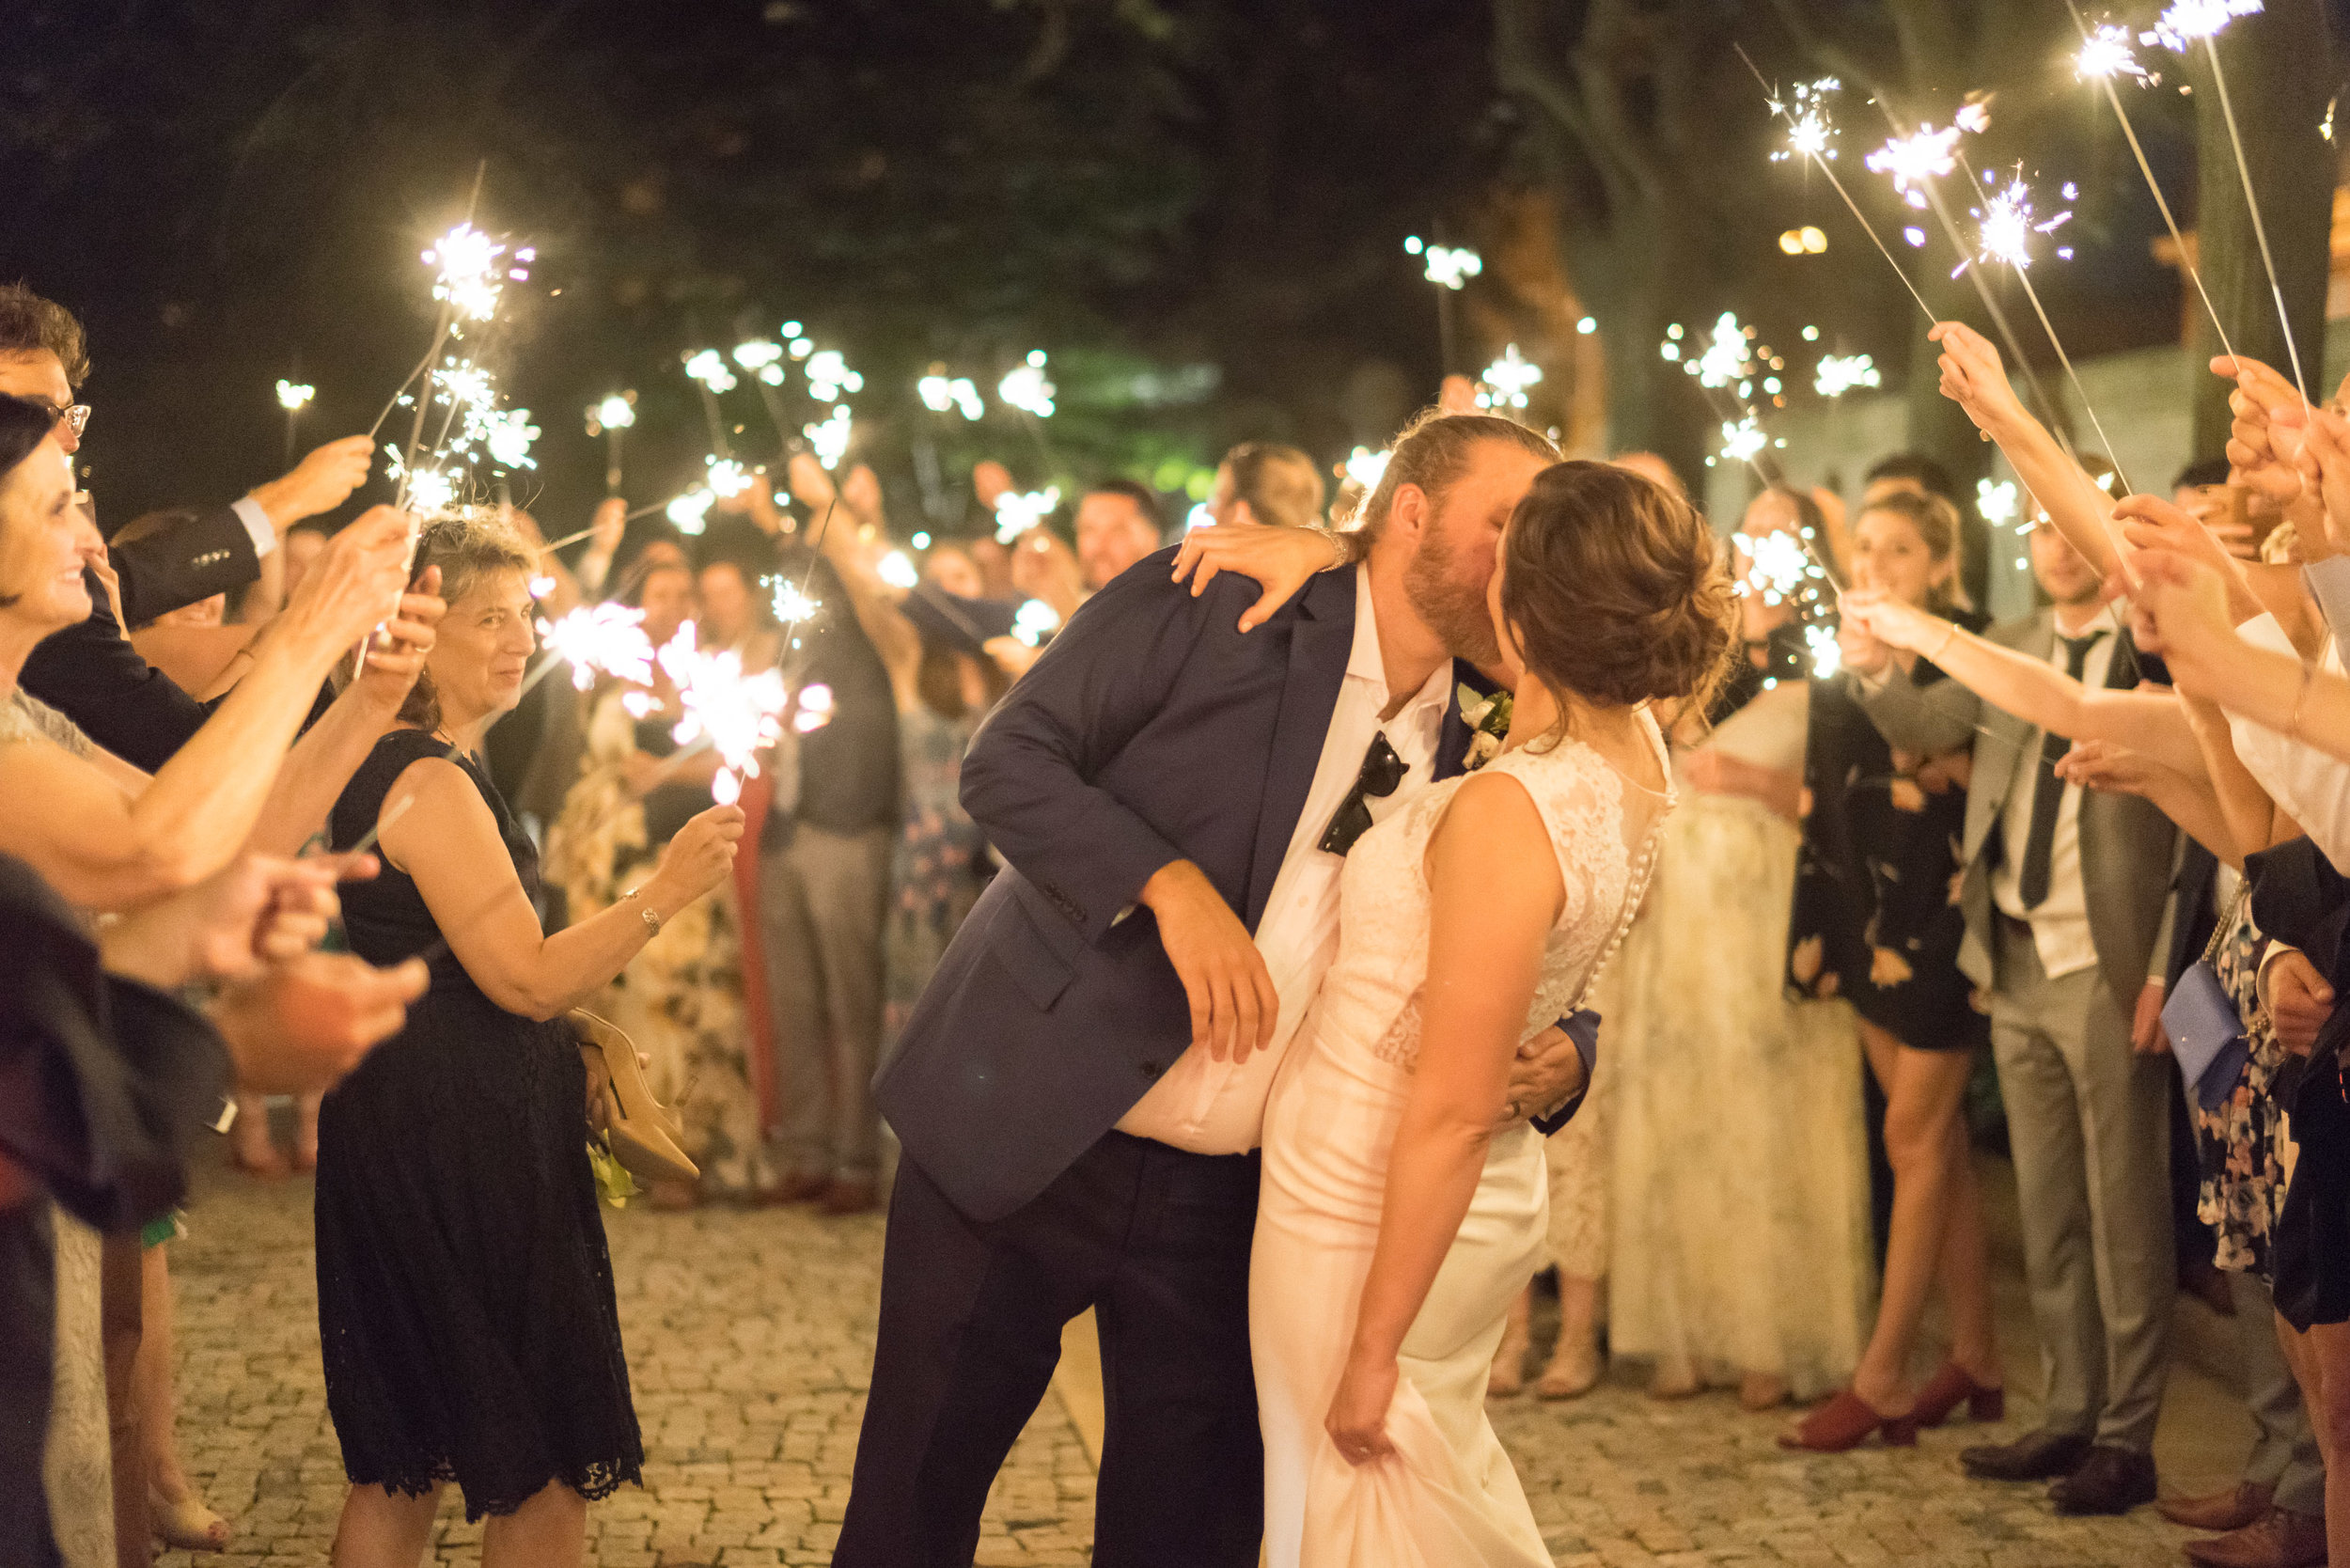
[1502,461,1737,708]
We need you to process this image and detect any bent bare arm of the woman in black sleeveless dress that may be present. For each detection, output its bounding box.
[379,757,743,1018]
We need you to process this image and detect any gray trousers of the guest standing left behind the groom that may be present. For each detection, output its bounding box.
[760,825,896,1183]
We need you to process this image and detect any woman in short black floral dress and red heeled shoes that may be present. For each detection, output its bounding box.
[1779,494,2005,1452]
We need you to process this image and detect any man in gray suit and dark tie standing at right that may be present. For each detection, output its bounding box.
[1859,522,2179,1513]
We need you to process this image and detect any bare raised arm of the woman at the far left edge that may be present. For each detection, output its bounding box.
[0,508,409,910]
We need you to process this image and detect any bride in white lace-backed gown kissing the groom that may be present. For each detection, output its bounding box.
[1213,463,1732,1568]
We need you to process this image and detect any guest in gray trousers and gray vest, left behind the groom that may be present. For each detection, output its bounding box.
[760,562,901,1213]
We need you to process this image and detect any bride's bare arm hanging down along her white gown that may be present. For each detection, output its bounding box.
[1328,774,1565,1465]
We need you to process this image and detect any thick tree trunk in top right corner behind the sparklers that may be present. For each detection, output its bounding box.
[2186,0,2336,459]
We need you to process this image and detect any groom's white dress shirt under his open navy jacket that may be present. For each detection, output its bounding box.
[1119,567,1452,1154]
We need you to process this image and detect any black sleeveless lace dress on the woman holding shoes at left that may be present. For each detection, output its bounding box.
[318,729,644,1518]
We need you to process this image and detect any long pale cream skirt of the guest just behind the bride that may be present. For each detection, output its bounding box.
[1601,794,1875,1396]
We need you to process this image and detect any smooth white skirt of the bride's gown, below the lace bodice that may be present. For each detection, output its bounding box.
[1248,1042,1551,1568]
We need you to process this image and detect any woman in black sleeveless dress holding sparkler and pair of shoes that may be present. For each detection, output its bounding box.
[318,520,743,1568]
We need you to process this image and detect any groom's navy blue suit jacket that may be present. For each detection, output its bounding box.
[874,550,1589,1220]
